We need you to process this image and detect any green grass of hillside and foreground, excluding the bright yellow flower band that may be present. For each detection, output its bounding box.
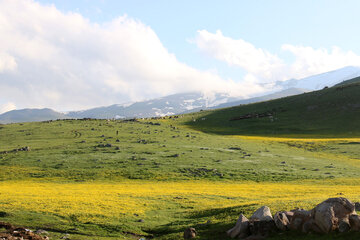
[0,84,360,239]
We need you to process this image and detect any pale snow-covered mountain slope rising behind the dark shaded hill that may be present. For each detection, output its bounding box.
[276,66,360,90]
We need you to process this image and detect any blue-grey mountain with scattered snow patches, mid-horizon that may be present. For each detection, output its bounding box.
[67,92,236,118]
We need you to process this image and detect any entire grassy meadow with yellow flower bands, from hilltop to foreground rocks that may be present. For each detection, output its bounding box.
[0,82,360,240]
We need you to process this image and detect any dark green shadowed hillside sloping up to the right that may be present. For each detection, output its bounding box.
[187,78,360,137]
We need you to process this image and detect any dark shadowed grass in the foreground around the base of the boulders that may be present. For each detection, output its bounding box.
[150,204,360,240]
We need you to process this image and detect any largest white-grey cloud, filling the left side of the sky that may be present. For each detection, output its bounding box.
[0,0,262,110]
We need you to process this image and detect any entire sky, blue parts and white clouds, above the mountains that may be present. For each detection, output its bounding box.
[0,0,360,113]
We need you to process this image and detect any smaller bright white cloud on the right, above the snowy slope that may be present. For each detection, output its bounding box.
[193,30,360,83]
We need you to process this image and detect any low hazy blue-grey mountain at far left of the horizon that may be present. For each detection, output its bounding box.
[0,108,66,123]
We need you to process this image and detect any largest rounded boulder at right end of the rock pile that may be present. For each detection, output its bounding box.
[313,197,356,233]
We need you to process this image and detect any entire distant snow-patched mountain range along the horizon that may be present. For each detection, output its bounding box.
[0,67,360,123]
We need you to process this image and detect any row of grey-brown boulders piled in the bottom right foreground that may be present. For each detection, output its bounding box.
[227,197,360,240]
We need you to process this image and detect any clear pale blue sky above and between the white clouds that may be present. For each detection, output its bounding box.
[40,0,360,76]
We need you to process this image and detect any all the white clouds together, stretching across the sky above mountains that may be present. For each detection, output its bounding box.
[0,0,360,113]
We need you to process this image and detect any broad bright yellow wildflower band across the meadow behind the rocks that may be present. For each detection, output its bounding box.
[0,179,360,221]
